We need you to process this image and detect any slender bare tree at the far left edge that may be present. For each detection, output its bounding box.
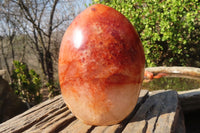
[0,0,20,76]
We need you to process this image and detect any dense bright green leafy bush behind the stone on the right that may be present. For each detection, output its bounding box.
[93,0,200,67]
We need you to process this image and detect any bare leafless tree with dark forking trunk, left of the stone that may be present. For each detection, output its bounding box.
[0,0,74,95]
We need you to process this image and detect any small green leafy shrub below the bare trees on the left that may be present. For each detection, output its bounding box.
[11,61,42,106]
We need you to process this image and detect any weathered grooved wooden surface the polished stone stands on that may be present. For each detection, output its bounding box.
[0,90,185,133]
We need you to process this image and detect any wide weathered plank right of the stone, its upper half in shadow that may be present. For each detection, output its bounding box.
[123,91,184,133]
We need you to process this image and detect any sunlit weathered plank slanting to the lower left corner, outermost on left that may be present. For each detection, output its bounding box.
[0,96,65,133]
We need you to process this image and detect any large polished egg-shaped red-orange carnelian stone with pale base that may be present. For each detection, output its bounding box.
[59,4,145,125]
